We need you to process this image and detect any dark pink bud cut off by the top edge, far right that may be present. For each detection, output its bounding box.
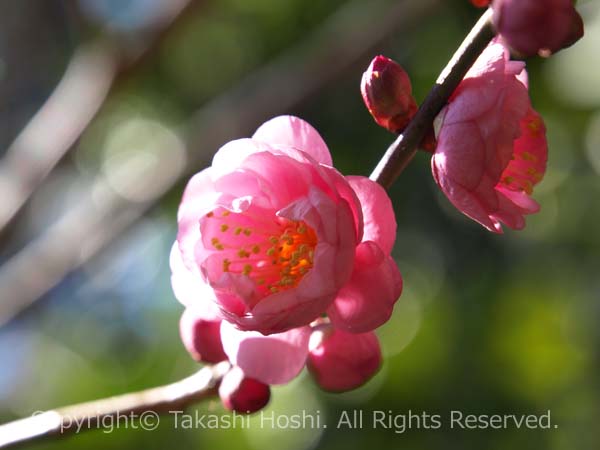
[492,0,583,56]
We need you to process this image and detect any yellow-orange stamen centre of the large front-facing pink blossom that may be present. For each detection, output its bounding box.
[207,210,317,296]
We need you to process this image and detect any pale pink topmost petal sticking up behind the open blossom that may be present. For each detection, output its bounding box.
[252,116,333,166]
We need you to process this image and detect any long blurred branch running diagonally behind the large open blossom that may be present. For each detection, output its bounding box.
[0,0,441,326]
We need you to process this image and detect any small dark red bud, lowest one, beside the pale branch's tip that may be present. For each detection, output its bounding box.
[219,367,271,414]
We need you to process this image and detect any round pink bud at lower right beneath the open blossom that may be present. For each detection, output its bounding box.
[307,328,381,392]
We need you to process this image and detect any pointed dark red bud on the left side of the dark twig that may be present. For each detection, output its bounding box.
[360,55,417,133]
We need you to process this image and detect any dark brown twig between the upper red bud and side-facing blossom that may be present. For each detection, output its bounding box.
[370,9,494,189]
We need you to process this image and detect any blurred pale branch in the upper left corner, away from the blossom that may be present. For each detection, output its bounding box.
[0,0,198,232]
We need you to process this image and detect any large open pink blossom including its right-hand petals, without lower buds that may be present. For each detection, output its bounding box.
[171,116,401,338]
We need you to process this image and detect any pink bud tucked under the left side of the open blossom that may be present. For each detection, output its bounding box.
[179,308,227,363]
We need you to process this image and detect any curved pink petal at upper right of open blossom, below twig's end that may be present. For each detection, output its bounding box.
[346,176,396,255]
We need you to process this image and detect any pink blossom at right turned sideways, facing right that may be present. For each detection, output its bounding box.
[431,43,548,233]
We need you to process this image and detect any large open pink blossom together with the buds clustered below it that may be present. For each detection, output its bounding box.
[171,116,402,412]
